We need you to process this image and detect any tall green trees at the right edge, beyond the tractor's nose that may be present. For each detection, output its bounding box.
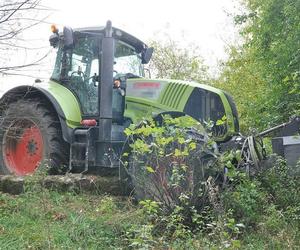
[217,0,300,133]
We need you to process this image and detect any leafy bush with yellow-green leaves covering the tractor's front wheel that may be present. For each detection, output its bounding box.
[122,116,251,248]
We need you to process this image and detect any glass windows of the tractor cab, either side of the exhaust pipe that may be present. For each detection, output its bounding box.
[51,35,143,116]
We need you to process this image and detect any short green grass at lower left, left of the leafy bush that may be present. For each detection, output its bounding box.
[0,190,141,249]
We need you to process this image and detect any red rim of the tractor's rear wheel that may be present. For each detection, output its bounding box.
[3,120,44,175]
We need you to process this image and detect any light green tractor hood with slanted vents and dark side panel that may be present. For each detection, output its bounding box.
[125,78,239,140]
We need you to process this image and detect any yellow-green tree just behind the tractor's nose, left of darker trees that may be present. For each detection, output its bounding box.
[215,47,269,133]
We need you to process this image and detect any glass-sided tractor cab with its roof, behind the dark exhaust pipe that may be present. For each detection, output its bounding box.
[50,27,151,120]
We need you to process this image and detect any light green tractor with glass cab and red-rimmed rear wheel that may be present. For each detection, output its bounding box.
[0,21,242,175]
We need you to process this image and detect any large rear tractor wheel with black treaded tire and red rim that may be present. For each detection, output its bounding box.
[0,99,69,176]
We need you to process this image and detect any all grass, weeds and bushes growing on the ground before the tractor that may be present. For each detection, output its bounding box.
[0,118,300,249]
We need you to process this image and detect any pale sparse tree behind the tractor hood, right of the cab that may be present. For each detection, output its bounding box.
[149,39,208,83]
